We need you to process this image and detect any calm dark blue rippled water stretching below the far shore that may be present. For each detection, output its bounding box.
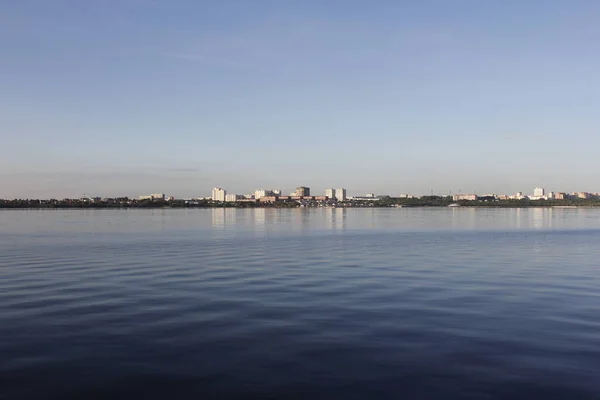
[0,208,600,399]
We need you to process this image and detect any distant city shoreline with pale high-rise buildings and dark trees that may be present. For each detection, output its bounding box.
[0,186,600,208]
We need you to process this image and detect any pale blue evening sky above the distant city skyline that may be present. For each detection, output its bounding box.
[0,0,600,198]
